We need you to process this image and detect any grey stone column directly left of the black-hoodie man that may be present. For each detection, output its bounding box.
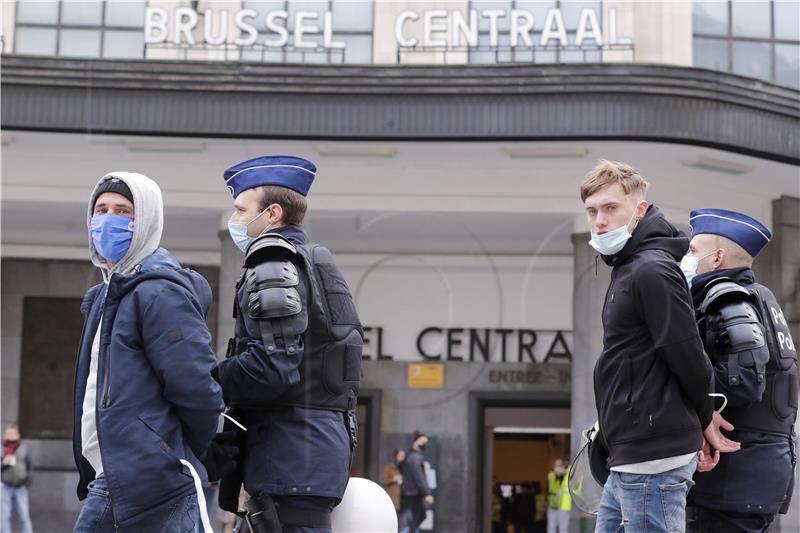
[571,232,611,457]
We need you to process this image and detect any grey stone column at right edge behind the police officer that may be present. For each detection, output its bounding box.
[753,196,800,532]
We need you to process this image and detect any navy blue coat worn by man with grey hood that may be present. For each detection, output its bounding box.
[73,248,224,526]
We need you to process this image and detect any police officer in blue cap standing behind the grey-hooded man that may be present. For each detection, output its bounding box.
[215,156,363,533]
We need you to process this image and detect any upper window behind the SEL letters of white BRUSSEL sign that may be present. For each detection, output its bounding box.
[241,0,374,64]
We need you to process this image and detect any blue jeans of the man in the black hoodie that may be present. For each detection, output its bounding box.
[594,457,697,533]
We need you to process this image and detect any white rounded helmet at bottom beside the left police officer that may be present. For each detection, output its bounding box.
[331,477,397,533]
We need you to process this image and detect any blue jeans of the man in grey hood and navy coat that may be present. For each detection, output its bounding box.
[75,475,202,533]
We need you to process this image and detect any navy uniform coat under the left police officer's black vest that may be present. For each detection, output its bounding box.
[217,225,352,500]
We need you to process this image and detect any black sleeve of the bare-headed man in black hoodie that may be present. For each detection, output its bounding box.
[634,261,714,429]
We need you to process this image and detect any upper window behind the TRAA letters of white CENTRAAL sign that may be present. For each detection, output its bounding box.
[469,0,603,64]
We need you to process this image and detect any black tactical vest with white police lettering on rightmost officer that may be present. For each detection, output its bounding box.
[712,283,798,436]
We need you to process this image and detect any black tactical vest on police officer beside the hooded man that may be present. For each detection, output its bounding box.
[230,234,363,411]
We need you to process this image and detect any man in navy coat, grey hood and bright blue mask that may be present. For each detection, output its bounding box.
[73,172,223,532]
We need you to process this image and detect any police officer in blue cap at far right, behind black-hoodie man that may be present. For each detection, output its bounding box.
[681,209,798,533]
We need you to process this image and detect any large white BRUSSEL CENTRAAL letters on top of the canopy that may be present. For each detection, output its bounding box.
[145,4,630,49]
